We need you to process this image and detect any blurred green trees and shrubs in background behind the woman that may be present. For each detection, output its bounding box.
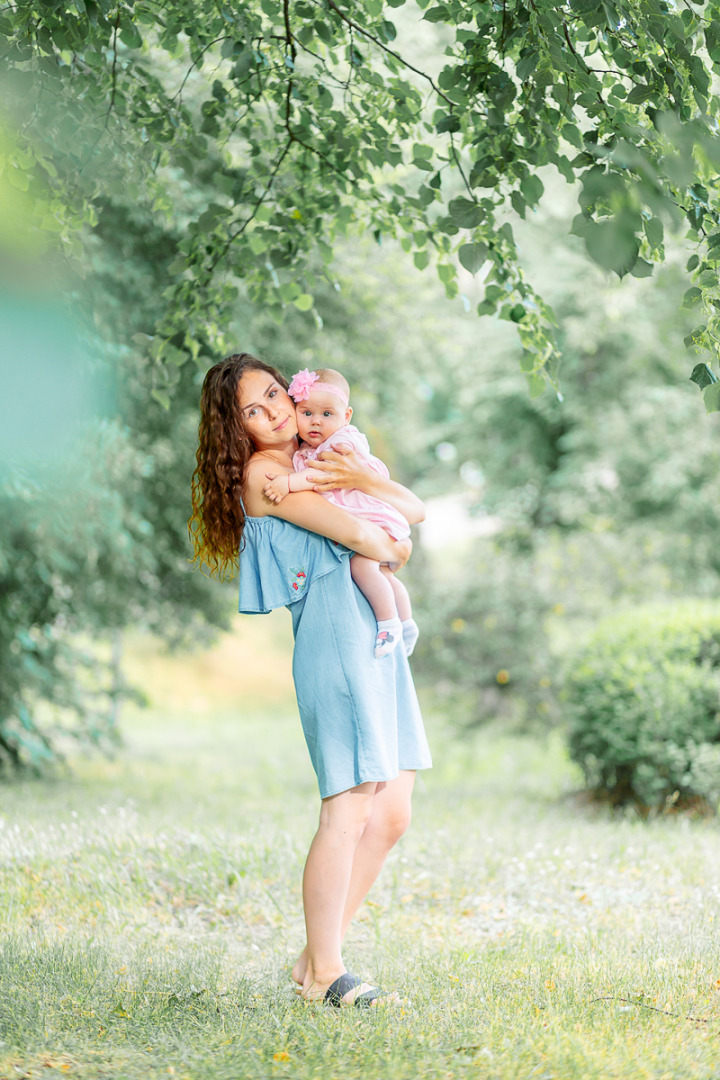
[0,5,720,812]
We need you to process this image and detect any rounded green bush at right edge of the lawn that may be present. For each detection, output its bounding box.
[563,600,720,809]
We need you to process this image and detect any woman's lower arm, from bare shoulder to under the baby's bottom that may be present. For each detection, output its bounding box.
[245,461,412,570]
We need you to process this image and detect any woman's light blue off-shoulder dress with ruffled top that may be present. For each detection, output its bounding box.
[240,515,432,798]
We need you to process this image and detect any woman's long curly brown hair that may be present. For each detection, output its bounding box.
[188,352,287,581]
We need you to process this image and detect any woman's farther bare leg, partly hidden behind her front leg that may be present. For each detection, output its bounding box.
[293,771,415,985]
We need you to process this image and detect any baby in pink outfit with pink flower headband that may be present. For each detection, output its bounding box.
[264,367,418,659]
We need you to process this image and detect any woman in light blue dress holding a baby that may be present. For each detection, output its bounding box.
[190,353,431,1005]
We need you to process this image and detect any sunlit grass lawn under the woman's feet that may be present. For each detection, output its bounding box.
[0,617,720,1080]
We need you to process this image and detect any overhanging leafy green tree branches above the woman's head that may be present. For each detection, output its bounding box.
[0,0,720,410]
